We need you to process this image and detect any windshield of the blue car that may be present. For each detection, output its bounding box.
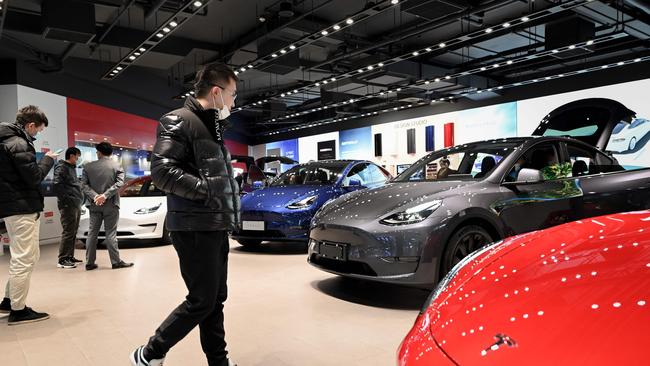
[271,162,348,187]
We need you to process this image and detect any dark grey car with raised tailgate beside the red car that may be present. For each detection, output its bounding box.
[308,99,650,288]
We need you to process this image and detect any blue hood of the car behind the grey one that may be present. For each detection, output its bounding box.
[241,185,334,211]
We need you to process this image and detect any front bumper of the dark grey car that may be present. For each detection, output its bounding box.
[308,219,443,288]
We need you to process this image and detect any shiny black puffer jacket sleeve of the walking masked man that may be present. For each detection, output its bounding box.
[151,115,210,202]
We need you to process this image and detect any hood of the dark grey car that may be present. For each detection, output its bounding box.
[314,181,476,224]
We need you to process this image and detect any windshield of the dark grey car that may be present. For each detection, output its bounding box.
[394,140,522,182]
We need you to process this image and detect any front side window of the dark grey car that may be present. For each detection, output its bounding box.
[506,142,560,182]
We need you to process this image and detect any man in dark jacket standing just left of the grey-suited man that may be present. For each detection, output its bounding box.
[54,147,84,269]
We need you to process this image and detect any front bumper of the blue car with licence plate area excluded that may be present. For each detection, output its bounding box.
[231,211,313,243]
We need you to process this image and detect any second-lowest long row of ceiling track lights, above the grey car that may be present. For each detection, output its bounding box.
[251,32,627,122]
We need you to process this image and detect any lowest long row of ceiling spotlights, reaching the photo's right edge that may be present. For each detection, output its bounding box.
[264,56,650,136]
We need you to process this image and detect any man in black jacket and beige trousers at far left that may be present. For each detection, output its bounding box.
[0,105,58,325]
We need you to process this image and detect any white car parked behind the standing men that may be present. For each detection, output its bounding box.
[77,176,170,243]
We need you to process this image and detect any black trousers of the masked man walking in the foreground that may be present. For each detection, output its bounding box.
[144,231,229,366]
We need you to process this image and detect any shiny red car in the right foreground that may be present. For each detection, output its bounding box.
[398,211,650,366]
